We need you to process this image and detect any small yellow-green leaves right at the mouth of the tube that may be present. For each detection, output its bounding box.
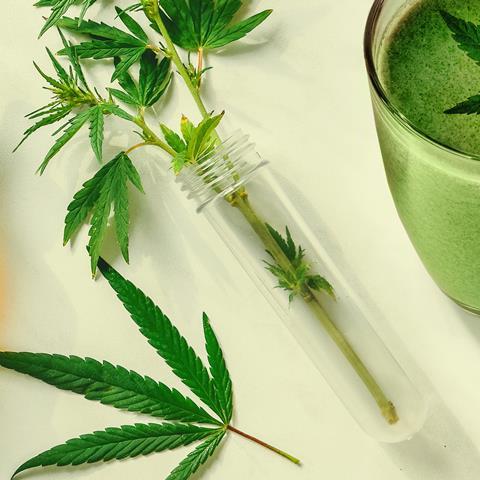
[160,112,224,174]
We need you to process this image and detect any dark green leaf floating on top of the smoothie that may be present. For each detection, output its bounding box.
[440,11,480,115]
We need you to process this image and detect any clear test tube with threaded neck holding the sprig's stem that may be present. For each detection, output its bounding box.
[178,132,427,442]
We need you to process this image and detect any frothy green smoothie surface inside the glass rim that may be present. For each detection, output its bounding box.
[379,0,480,154]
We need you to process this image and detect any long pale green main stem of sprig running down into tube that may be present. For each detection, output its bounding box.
[149,5,399,424]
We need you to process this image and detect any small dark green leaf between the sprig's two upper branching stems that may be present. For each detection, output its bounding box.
[109,50,172,108]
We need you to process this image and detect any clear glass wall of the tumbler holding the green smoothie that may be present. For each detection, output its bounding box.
[365,0,480,314]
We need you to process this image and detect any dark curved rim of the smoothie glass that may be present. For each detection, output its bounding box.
[363,0,480,162]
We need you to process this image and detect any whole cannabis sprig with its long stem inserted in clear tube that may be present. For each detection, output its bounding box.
[17,0,398,424]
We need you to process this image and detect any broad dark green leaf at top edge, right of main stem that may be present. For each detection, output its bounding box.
[154,0,272,51]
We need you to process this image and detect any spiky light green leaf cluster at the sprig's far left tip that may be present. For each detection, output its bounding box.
[15,41,133,173]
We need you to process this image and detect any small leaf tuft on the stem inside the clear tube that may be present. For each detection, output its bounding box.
[265,224,335,301]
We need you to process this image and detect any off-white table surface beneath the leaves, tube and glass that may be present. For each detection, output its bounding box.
[0,0,480,480]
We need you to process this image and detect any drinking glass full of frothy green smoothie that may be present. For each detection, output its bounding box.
[365,0,480,314]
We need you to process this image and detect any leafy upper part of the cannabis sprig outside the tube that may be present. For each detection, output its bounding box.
[26,0,271,278]
